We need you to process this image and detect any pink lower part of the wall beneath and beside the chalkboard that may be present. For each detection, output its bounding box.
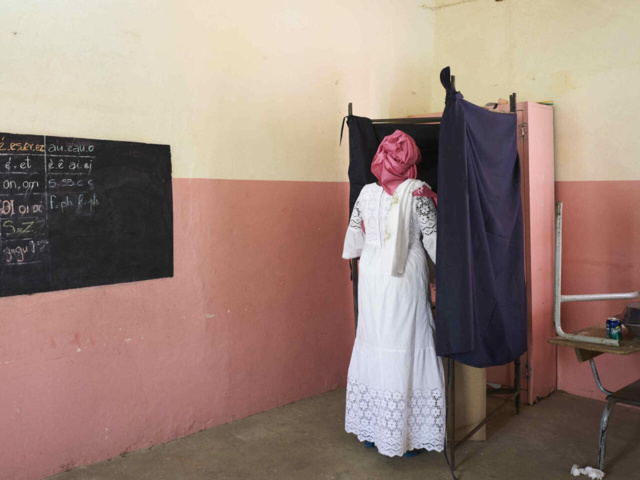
[0,179,353,480]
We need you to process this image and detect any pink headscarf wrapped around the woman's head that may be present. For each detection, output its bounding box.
[371,130,422,195]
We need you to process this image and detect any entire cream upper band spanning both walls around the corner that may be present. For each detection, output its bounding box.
[0,0,640,181]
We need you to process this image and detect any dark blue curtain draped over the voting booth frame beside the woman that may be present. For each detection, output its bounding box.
[435,68,527,367]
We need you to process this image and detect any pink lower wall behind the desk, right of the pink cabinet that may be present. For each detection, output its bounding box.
[556,180,640,399]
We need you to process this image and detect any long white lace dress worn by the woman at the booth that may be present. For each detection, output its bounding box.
[342,183,445,456]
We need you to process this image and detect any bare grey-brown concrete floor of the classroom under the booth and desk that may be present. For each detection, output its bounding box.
[49,389,640,480]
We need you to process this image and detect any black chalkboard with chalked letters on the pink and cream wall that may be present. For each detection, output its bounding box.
[0,133,173,296]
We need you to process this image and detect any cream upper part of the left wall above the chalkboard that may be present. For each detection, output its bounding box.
[0,0,437,181]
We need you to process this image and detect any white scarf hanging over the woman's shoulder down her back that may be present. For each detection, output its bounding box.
[382,178,423,277]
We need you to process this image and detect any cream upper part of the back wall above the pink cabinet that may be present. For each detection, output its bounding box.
[431,0,640,181]
